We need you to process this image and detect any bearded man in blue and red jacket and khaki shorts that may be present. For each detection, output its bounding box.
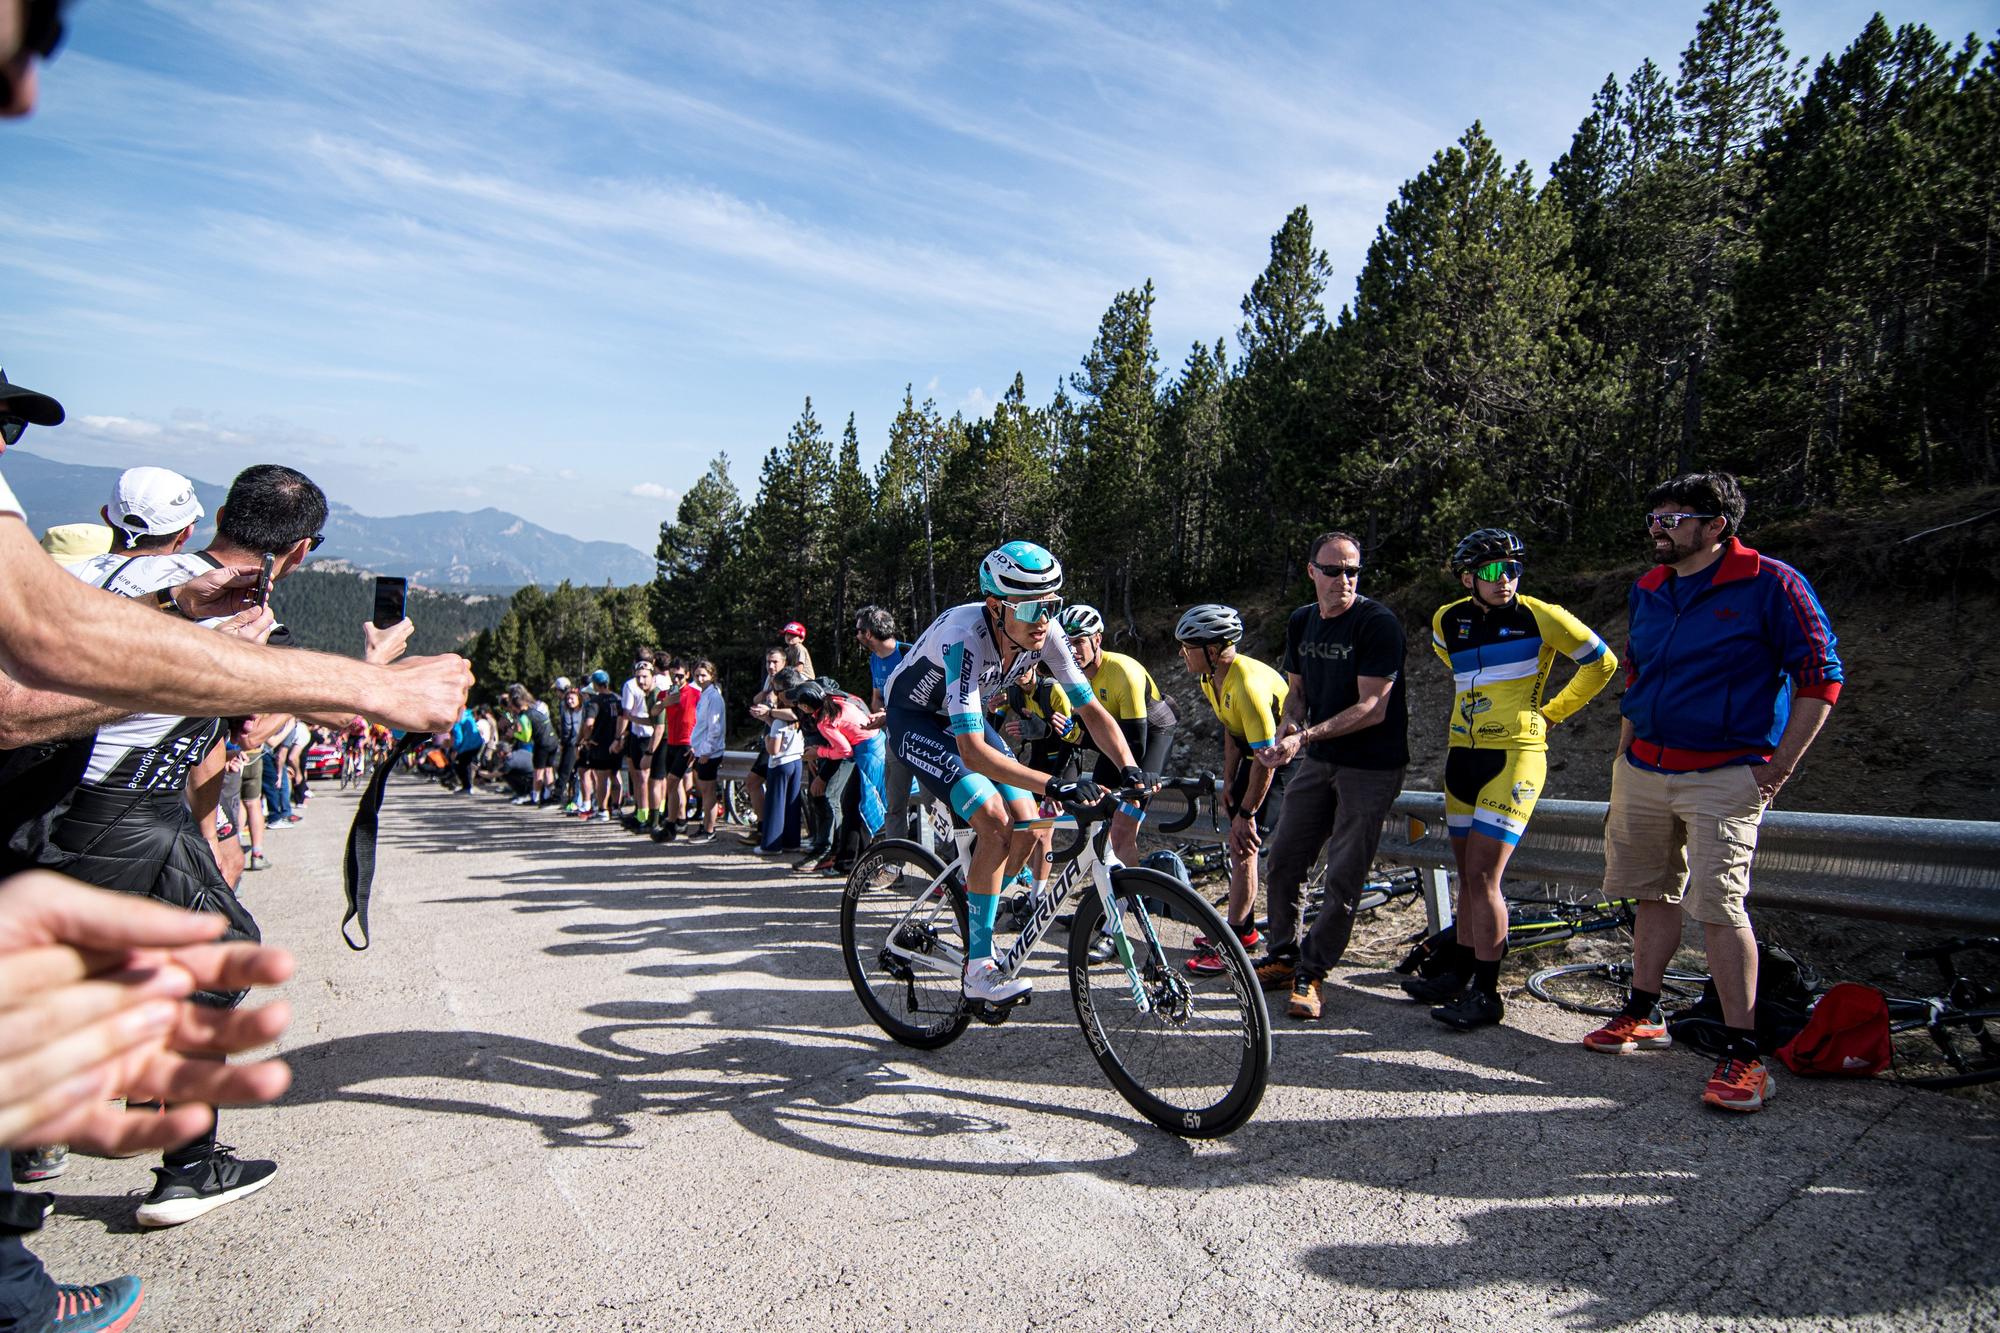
[1584,472,1842,1111]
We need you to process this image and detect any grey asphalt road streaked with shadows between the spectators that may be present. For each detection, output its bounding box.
[32,781,2000,1331]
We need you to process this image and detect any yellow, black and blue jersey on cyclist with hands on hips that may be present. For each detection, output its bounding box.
[1430,596,1618,751]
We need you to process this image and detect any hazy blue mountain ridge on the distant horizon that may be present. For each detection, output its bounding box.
[0,448,654,588]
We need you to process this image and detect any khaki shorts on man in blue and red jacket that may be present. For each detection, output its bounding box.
[1604,755,1764,927]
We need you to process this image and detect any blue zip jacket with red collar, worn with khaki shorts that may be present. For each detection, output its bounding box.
[1618,536,1842,773]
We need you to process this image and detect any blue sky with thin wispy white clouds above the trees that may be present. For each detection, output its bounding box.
[0,0,1994,550]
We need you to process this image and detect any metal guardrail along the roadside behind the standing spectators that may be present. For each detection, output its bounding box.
[722,751,2000,931]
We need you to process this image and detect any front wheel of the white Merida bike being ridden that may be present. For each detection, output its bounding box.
[1070,869,1270,1139]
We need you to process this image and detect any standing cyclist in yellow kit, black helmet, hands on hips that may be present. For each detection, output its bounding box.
[1404,528,1618,1029]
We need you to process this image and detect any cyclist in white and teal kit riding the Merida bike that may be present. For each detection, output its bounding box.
[882,542,1146,1005]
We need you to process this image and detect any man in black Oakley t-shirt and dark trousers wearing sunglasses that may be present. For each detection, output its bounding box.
[1256,532,1410,1019]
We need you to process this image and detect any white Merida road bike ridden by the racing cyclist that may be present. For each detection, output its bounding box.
[840,793,1272,1139]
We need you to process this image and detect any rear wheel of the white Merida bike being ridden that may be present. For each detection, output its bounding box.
[840,839,972,1051]
